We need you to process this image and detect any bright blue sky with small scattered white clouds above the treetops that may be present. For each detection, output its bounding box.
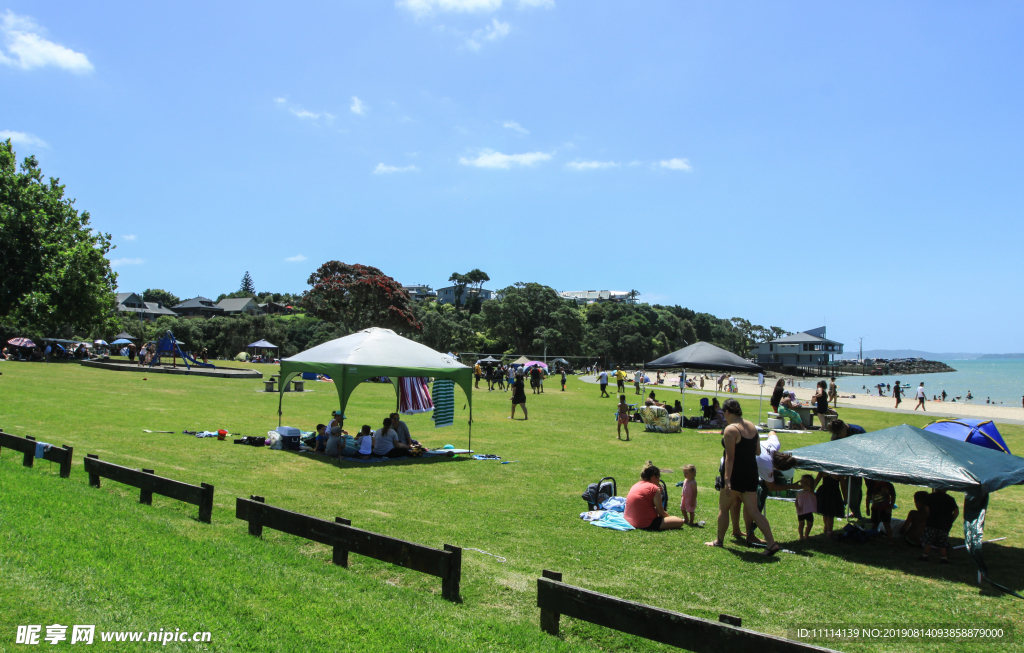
[0,0,1024,352]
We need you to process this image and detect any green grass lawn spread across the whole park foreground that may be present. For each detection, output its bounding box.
[0,361,1024,651]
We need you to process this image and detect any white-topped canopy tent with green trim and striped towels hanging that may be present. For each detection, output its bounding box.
[278,327,473,448]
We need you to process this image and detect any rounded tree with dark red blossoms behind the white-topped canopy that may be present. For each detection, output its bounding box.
[302,261,423,333]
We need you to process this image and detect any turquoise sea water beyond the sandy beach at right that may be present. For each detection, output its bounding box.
[827,359,1024,406]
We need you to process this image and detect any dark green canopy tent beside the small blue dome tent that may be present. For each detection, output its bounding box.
[790,424,1024,598]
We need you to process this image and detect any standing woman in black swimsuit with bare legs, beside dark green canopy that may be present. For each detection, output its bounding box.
[706,399,779,556]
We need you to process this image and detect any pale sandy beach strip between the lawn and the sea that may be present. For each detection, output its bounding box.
[585,372,1024,424]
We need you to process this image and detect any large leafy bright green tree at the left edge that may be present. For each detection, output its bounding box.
[0,139,117,338]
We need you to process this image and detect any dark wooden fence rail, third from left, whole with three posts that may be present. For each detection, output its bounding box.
[234,496,462,603]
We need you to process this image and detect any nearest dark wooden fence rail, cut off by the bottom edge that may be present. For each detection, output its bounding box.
[537,570,835,653]
